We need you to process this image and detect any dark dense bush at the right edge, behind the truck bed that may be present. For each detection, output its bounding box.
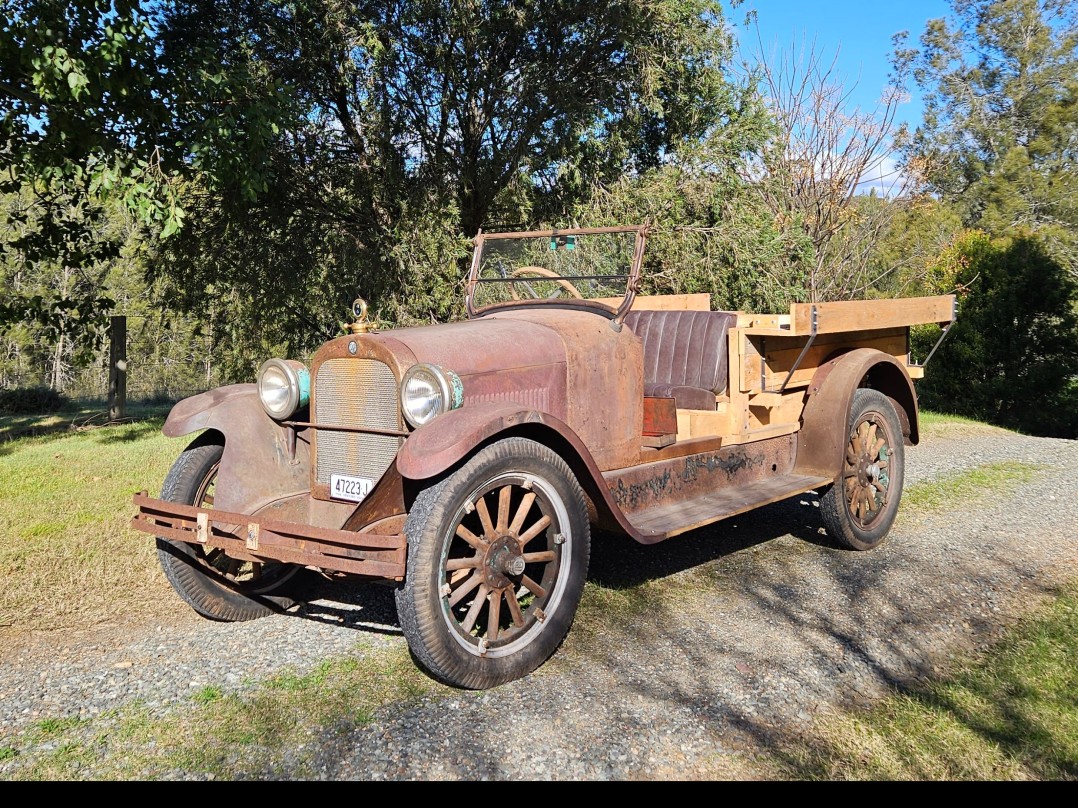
[914,231,1078,437]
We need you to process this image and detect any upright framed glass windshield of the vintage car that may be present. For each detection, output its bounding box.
[468,227,644,314]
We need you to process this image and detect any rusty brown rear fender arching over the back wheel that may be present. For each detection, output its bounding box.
[794,348,920,477]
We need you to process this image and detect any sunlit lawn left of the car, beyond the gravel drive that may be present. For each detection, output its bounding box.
[0,405,186,631]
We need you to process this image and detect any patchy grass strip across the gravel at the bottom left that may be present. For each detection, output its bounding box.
[0,645,455,780]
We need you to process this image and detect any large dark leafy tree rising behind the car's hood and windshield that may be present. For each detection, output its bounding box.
[160,0,754,350]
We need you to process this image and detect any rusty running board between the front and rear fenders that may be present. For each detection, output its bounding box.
[625,474,832,543]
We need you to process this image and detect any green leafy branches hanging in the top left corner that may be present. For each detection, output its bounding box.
[0,0,182,342]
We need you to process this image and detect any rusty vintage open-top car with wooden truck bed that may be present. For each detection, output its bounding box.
[133,226,956,688]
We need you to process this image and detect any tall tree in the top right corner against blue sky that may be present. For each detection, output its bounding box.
[895,0,1078,274]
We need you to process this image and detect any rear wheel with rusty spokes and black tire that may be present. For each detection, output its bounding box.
[819,388,906,551]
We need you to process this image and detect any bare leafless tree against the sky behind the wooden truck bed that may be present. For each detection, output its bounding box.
[747,30,911,301]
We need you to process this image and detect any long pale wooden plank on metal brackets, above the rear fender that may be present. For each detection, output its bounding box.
[790,294,955,334]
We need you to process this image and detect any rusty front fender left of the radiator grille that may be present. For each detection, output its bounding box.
[162,384,310,513]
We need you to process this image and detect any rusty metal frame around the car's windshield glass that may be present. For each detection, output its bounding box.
[465,224,649,325]
